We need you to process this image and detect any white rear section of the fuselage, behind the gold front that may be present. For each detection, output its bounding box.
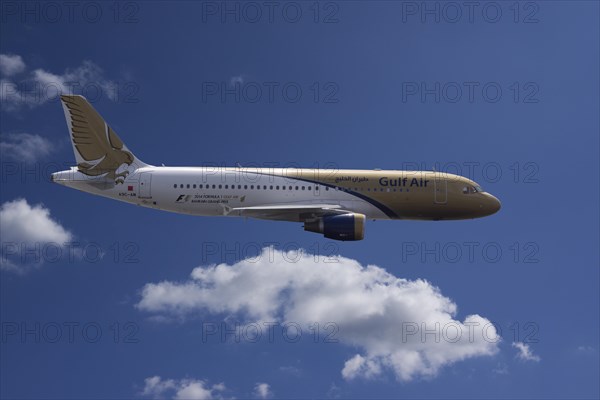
[53,167,388,219]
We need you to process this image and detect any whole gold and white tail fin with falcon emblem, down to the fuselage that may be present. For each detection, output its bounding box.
[60,95,148,183]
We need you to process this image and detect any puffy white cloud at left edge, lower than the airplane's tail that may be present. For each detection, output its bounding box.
[0,199,72,272]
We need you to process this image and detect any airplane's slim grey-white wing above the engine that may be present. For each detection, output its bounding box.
[225,204,350,222]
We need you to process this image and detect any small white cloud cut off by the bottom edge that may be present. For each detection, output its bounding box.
[141,376,226,400]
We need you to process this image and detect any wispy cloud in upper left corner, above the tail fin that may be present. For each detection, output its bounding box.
[0,56,118,112]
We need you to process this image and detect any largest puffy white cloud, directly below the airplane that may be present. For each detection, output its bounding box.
[137,248,500,381]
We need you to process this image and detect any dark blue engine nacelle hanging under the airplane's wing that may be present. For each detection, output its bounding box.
[304,213,366,241]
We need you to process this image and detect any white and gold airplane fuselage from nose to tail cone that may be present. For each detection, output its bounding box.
[52,166,500,220]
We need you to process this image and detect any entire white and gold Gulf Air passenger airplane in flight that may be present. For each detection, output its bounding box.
[51,95,501,241]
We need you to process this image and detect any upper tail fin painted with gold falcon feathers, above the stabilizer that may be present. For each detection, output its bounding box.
[61,95,133,169]
